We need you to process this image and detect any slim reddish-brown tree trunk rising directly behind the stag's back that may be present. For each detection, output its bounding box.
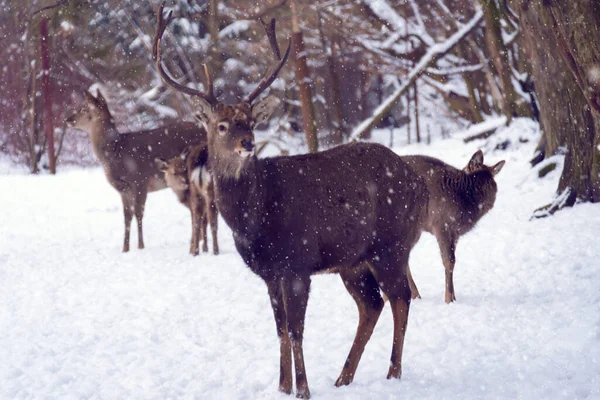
[291,0,319,153]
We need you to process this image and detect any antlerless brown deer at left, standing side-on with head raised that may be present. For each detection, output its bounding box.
[66,90,206,252]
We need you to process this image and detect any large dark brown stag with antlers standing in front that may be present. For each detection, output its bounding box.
[154,3,428,398]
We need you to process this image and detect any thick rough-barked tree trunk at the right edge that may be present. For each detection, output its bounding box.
[513,0,600,214]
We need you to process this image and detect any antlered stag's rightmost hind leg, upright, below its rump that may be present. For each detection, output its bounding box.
[371,252,411,379]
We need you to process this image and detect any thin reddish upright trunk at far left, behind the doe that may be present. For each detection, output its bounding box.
[40,17,56,174]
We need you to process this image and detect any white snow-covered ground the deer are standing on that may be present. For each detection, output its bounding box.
[0,121,600,399]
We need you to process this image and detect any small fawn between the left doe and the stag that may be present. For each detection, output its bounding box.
[154,143,219,256]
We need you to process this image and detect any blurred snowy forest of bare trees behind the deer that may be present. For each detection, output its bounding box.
[0,0,600,209]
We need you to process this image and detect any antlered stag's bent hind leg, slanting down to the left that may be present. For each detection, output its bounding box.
[335,268,384,387]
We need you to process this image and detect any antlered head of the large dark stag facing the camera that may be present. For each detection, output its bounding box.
[152,3,291,172]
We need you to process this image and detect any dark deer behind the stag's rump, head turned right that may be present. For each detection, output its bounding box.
[402,150,504,303]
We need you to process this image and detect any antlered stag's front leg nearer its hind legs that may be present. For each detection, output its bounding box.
[282,274,310,399]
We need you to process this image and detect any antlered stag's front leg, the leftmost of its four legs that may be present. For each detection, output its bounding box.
[267,281,293,394]
